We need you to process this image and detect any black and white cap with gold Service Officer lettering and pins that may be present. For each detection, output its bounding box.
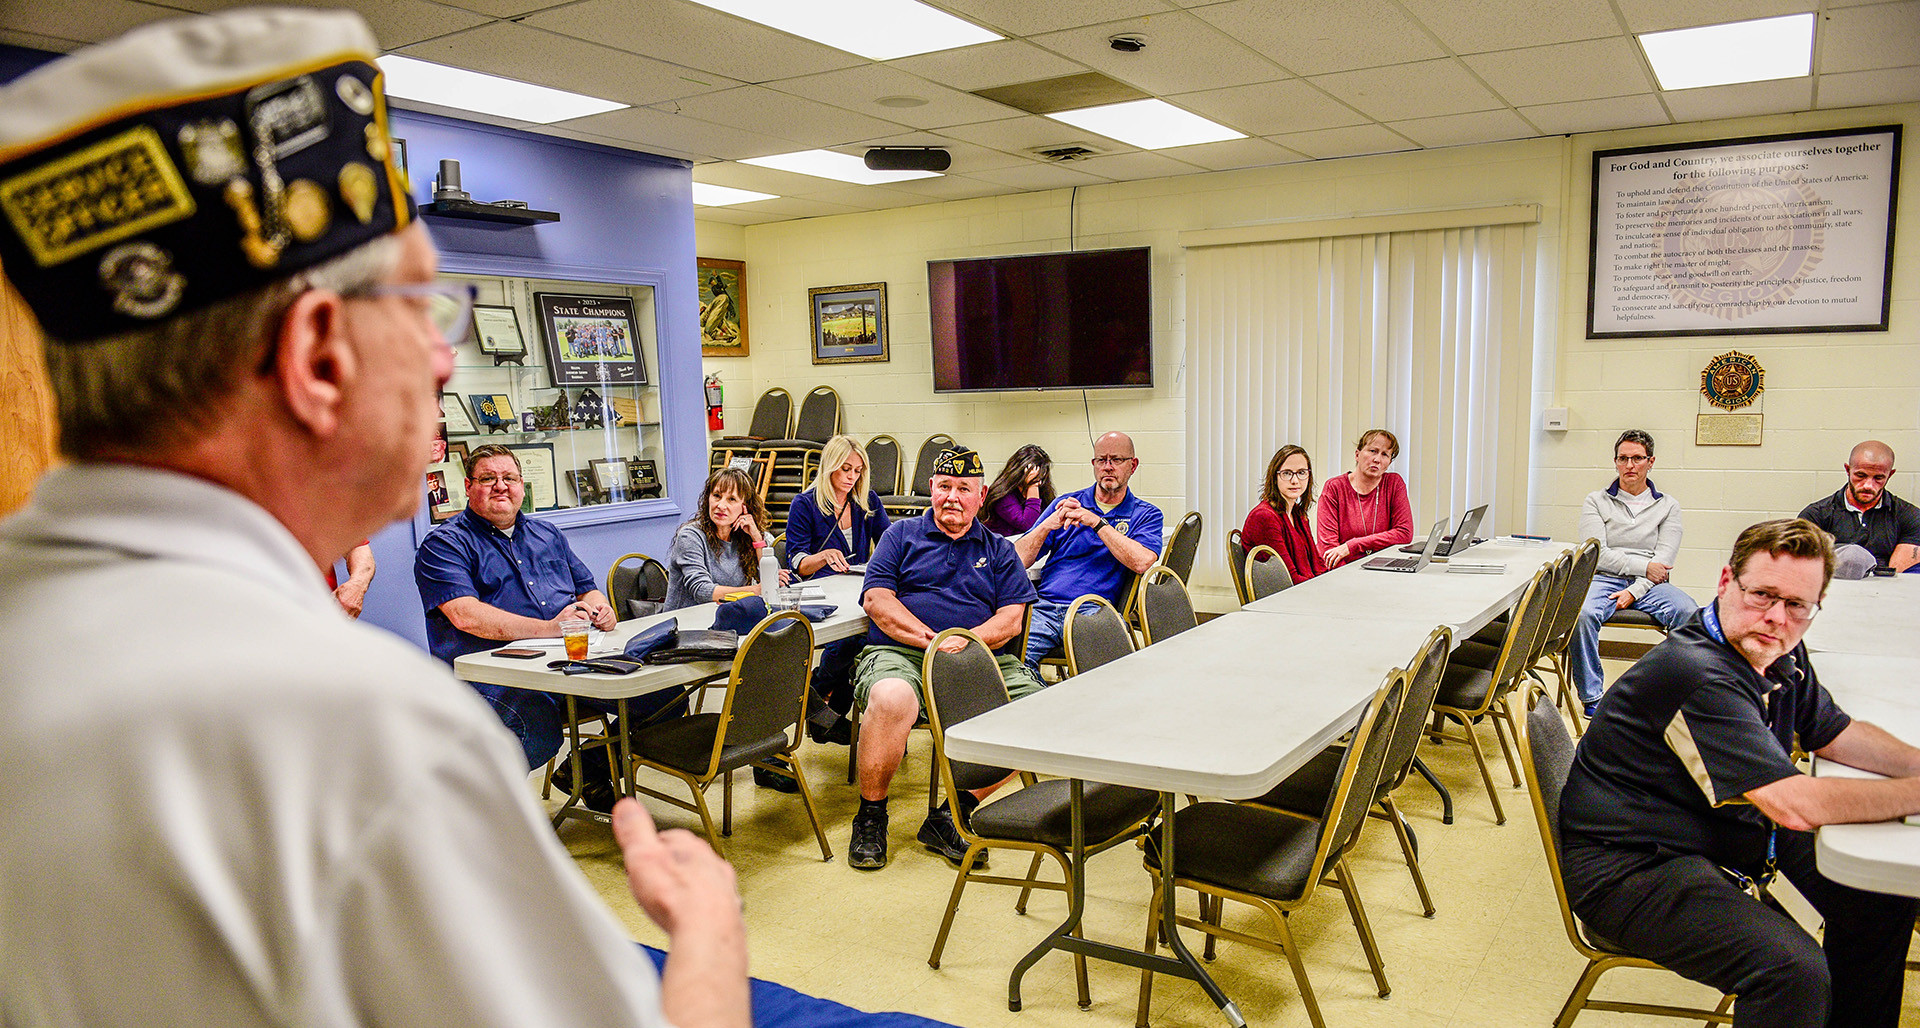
[0,8,413,342]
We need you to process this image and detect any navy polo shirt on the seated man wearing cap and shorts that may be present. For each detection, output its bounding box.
[860,513,1033,653]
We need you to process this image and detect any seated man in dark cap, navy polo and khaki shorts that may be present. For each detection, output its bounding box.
[847,450,1041,870]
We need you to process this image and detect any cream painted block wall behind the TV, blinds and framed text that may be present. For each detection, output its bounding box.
[695,104,1920,609]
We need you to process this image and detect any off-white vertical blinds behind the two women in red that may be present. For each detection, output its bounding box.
[1187,223,1538,588]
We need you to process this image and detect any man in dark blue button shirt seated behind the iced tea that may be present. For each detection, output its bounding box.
[413,444,645,795]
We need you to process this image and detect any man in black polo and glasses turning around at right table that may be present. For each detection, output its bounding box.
[1561,519,1920,1028]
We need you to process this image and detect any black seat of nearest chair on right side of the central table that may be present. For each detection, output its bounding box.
[1146,803,1321,903]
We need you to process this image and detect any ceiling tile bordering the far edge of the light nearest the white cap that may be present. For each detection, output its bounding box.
[403,21,739,106]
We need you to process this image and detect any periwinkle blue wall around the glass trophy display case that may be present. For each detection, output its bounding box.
[361,111,707,648]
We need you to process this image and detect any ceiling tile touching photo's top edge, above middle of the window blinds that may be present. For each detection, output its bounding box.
[1192,0,1446,75]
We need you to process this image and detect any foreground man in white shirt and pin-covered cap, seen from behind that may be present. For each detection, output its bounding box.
[0,10,749,1028]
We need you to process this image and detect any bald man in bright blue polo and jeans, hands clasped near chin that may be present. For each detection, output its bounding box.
[1014,432,1164,673]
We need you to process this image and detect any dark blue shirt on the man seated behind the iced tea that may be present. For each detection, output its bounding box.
[413,507,599,665]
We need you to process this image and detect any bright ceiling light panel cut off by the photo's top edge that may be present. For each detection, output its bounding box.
[693,0,1006,61]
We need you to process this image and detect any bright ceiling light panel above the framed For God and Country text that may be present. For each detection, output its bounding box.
[1640,13,1812,88]
